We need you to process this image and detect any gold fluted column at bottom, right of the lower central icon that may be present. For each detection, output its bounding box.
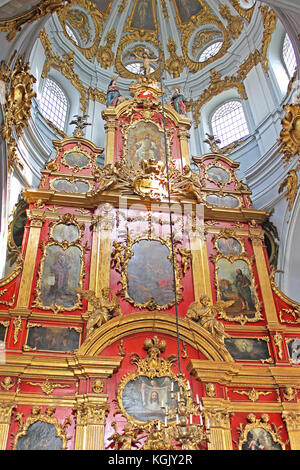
[203,399,232,450]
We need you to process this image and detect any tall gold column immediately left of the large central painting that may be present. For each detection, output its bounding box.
[95,203,115,296]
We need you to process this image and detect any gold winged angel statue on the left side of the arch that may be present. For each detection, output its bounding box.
[76,287,122,336]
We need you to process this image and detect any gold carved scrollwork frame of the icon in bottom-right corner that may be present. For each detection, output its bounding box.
[238,413,285,450]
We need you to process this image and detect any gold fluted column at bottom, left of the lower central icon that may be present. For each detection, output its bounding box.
[75,402,109,450]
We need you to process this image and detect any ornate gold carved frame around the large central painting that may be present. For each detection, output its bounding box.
[112,233,183,310]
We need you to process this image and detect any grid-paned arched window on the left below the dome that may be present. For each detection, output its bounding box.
[40,78,68,130]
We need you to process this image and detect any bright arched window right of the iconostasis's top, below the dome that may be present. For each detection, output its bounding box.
[211,100,249,147]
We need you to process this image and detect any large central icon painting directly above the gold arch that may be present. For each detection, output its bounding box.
[122,239,182,310]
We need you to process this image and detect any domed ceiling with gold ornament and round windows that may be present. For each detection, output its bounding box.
[32,0,268,112]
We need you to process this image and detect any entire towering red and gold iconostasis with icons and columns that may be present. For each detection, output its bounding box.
[0,81,300,450]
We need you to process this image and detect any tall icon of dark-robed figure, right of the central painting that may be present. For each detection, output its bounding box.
[215,256,261,323]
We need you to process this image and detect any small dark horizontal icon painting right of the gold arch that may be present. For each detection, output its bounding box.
[225,337,271,362]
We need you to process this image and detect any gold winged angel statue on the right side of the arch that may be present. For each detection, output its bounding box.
[186,294,234,343]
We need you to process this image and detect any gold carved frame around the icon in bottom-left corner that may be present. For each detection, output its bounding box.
[13,406,72,450]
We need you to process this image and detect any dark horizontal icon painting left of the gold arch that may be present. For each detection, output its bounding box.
[26,324,81,352]
